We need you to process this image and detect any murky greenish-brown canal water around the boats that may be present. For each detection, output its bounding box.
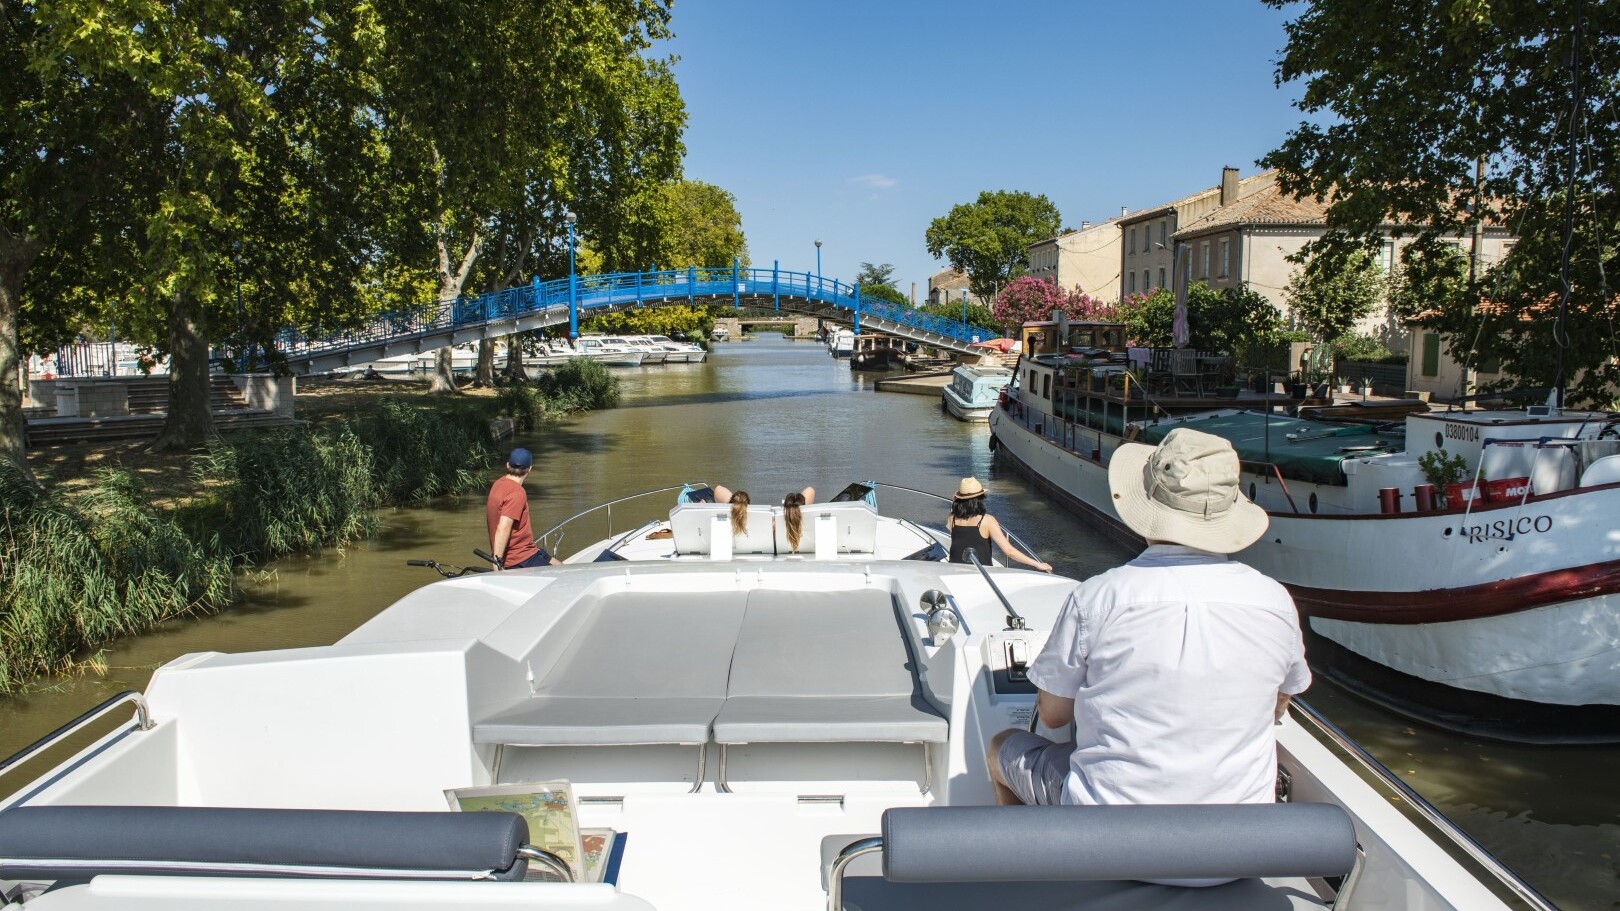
[0,336,1620,911]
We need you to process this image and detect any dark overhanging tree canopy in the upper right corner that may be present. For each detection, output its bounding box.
[1262,0,1620,404]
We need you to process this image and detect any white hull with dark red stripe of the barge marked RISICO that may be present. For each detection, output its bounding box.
[991,403,1620,705]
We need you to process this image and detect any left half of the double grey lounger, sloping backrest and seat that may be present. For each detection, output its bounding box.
[473,592,747,746]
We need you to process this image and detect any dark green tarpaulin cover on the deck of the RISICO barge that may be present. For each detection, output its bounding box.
[1140,412,1405,486]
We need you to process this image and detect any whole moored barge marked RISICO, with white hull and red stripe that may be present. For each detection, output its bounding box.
[990,316,1620,732]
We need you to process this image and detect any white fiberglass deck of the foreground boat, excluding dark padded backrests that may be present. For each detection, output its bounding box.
[0,556,1529,911]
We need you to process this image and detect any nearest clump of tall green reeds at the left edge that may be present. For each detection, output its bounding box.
[0,462,232,692]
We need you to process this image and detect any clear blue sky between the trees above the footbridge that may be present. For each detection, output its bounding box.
[664,0,1299,300]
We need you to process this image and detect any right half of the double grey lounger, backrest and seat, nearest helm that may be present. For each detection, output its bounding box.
[714,588,946,744]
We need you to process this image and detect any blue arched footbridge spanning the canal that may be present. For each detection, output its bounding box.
[275,266,990,373]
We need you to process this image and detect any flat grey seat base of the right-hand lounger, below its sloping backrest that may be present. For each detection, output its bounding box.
[714,695,949,744]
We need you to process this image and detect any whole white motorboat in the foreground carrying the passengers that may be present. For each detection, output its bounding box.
[0,488,1550,911]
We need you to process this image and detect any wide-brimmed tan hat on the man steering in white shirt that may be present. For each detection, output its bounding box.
[1108,426,1270,553]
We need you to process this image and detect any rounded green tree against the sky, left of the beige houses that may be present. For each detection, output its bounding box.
[923,190,1063,300]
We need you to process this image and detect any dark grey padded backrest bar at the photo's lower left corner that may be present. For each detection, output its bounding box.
[0,806,528,880]
